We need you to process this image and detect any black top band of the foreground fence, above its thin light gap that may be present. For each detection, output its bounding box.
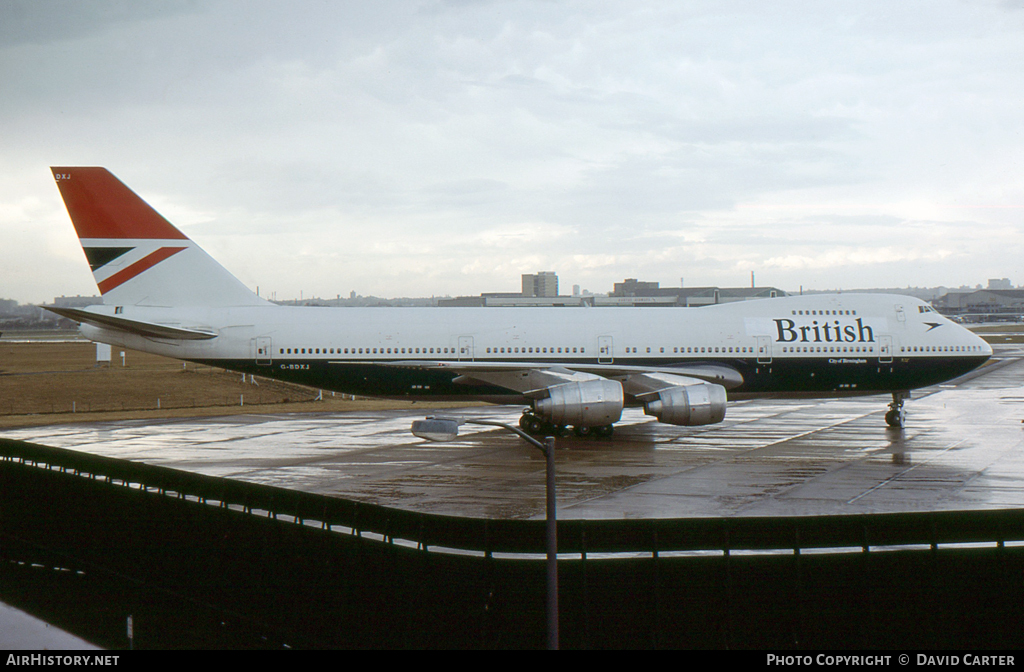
[6,438,1024,560]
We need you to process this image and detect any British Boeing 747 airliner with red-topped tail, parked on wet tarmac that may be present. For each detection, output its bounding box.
[48,168,992,435]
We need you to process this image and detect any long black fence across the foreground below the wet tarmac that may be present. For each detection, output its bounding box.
[0,439,1024,648]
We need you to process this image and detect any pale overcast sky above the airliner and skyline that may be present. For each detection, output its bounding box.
[0,0,1024,302]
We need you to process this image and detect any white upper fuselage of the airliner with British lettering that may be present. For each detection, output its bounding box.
[82,294,991,395]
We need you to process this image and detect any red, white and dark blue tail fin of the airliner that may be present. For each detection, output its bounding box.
[51,167,265,306]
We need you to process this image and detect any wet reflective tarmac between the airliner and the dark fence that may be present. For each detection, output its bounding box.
[2,347,1024,518]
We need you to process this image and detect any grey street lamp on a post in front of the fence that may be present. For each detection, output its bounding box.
[412,416,558,649]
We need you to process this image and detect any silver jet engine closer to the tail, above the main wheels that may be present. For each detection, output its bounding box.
[534,379,623,427]
